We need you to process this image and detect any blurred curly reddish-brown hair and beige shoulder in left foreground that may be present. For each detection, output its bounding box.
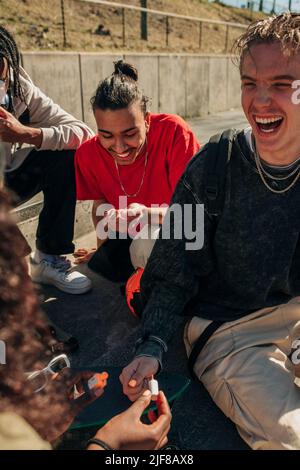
[0,177,70,448]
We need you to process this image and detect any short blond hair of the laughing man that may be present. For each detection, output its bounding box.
[233,12,300,70]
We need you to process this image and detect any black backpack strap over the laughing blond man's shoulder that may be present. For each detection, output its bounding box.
[203,129,237,216]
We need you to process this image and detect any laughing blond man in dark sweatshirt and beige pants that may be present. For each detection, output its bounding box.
[121,13,300,450]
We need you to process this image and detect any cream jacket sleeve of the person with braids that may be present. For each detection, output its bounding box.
[1,68,93,171]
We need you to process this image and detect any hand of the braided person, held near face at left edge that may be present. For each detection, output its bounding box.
[0,106,43,147]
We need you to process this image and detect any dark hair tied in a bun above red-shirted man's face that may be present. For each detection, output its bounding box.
[91,60,149,114]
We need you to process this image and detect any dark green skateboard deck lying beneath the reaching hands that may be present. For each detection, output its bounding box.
[70,367,190,430]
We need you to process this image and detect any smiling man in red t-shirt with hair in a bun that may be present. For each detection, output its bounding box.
[75,61,200,280]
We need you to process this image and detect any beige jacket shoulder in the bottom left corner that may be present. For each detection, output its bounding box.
[0,412,51,450]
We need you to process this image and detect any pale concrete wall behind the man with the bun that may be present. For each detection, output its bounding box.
[22,52,240,126]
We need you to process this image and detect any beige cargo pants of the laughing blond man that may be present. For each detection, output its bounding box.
[184,297,300,449]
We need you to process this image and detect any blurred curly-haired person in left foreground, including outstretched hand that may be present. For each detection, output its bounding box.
[0,160,171,450]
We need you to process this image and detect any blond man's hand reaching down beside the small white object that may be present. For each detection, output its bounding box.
[120,356,159,401]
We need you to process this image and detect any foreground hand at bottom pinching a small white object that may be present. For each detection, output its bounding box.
[88,390,172,450]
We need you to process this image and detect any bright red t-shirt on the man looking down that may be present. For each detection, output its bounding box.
[75,114,200,209]
